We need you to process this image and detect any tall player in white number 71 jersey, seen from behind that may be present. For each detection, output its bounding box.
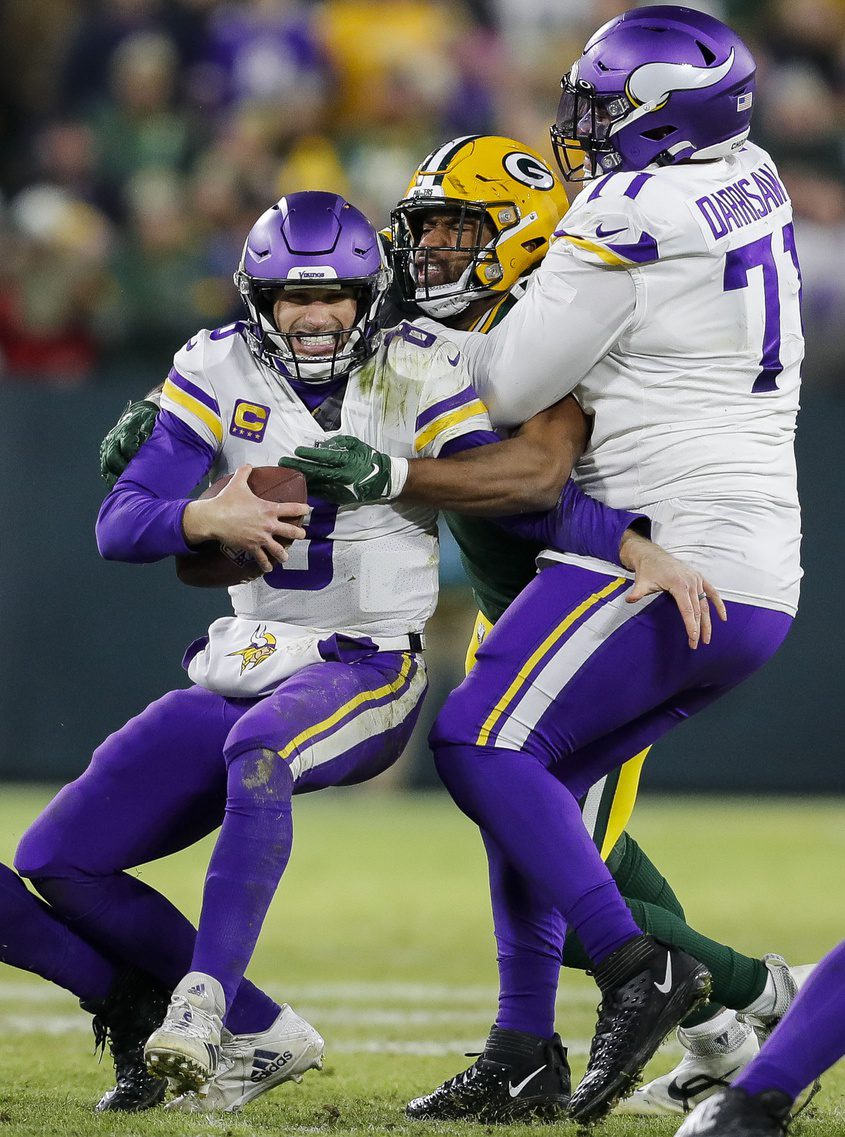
[280,6,803,1122]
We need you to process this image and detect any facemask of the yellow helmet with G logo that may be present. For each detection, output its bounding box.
[390,198,502,319]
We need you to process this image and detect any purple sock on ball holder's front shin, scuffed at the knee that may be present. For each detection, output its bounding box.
[190,750,293,1030]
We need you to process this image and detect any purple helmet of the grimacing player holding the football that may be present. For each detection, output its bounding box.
[234,191,390,383]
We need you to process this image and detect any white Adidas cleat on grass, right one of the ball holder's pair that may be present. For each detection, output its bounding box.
[166,1003,325,1113]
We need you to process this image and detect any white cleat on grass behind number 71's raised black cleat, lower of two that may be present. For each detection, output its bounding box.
[616,1010,760,1114]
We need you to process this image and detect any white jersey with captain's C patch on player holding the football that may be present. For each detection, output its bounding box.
[161,323,490,637]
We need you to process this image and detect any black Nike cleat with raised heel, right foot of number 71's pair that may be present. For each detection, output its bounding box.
[570,936,712,1124]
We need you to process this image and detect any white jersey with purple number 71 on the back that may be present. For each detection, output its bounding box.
[459,143,804,613]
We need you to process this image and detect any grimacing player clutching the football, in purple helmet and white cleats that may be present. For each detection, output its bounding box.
[16,193,664,1109]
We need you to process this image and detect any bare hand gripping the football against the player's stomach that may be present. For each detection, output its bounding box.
[182,465,309,572]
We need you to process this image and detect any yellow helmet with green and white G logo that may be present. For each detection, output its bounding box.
[390,134,569,319]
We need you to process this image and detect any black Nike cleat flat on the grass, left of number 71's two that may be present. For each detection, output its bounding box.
[405,1027,570,1124]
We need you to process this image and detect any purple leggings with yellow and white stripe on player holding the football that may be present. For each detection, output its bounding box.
[16,653,425,1034]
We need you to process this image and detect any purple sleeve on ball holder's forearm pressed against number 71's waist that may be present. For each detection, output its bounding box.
[498,480,652,564]
